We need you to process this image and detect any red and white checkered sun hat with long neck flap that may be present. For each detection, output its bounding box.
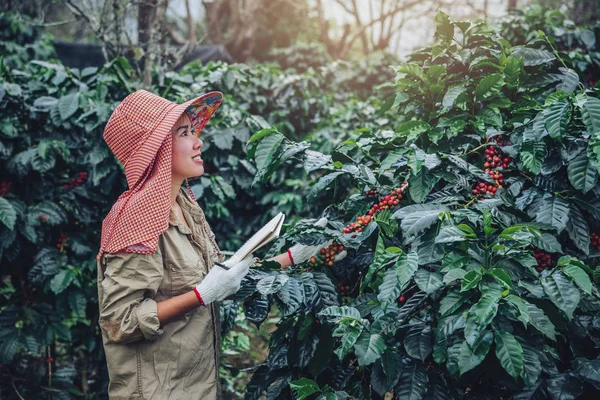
[97,90,223,258]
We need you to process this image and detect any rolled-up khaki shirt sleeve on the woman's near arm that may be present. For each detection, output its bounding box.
[98,249,164,343]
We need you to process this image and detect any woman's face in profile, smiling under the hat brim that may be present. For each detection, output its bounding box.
[171,113,204,179]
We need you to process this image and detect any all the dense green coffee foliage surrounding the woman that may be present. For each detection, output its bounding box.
[0,8,600,399]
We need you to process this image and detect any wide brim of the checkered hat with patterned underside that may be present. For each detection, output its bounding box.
[125,92,223,188]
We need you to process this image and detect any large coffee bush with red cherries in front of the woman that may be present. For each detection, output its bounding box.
[237,12,600,399]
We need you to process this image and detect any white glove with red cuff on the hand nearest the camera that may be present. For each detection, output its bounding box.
[194,255,254,306]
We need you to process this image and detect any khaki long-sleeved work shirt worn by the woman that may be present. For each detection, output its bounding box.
[98,189,223,400]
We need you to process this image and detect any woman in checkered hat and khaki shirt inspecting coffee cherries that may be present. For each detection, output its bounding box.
[97,90,327,399]
